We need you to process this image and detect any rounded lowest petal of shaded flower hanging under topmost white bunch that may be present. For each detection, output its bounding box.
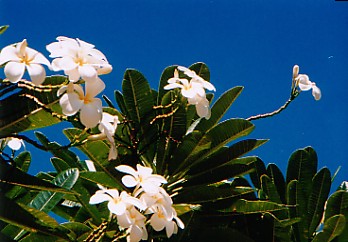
[80,102,102,128]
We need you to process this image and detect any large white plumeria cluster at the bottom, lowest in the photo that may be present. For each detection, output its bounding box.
[90,164,184,242]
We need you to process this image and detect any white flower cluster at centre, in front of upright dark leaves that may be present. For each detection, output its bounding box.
[164,66,215,119]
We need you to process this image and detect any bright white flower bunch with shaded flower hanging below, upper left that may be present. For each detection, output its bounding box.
[46,37,112,128]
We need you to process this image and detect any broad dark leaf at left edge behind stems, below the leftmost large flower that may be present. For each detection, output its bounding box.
[0,76,67,135]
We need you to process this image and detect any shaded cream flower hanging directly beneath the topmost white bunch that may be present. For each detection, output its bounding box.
[58,78,105,128]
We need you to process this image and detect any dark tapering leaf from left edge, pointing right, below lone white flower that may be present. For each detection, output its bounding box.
[0,162,72,193]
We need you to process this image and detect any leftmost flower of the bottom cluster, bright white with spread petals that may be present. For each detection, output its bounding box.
[89,189,146,215]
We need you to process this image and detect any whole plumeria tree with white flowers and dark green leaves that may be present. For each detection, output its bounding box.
[0,27,348,241]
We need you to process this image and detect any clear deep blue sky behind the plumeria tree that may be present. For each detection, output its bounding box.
[0,0,348,192]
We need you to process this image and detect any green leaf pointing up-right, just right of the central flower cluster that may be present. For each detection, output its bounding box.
[196,87,243,132]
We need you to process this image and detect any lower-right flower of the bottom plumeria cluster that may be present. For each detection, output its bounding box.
[150,208,185,238]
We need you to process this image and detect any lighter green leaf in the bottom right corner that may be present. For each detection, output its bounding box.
[312,214,346,242]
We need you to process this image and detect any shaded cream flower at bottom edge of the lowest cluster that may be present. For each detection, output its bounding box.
[117,206,148,242]
